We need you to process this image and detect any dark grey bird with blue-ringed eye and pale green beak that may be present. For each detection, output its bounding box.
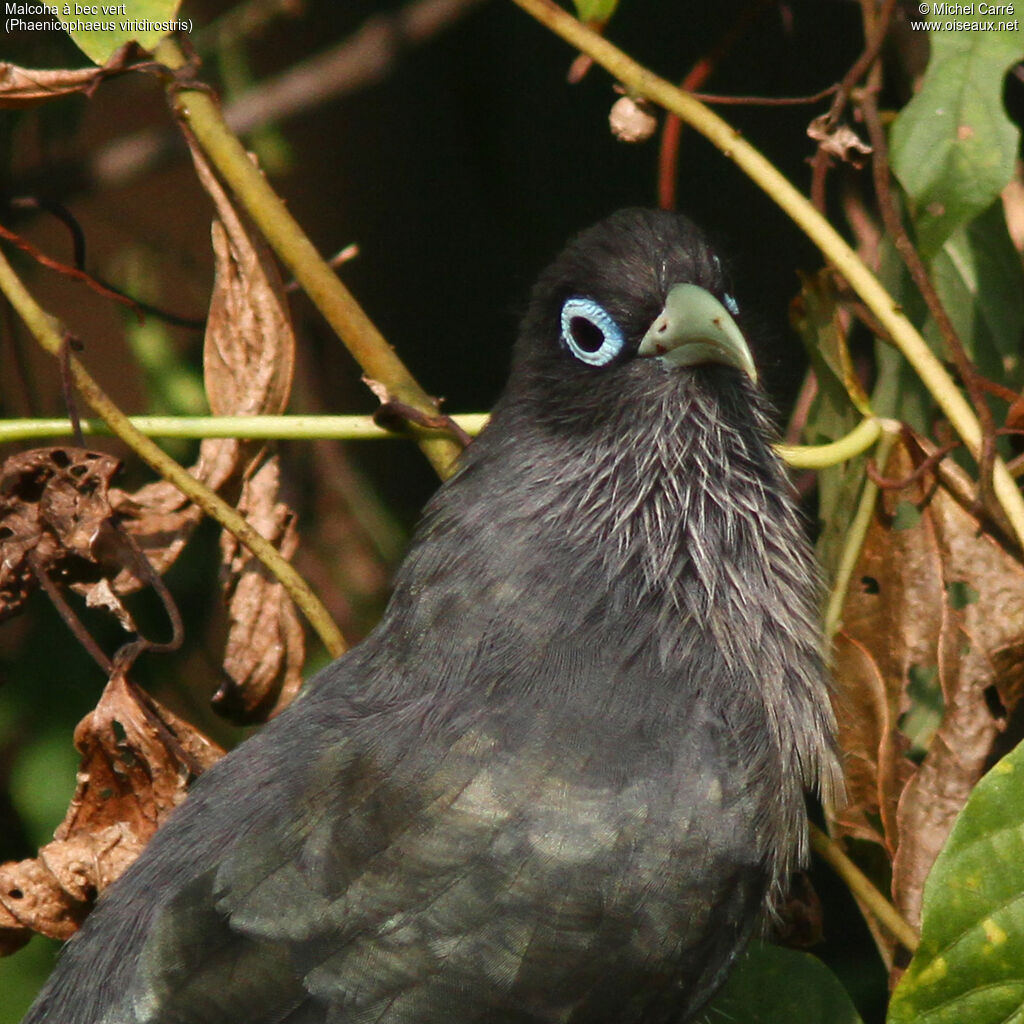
[25,208,839,1024]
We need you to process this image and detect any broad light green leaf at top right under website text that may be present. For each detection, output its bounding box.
[891,16,1024,258]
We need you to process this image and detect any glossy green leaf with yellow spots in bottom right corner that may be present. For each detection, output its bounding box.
[888,744,1024,1024]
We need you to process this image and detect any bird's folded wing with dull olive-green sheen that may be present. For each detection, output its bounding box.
[116,696,761,1024]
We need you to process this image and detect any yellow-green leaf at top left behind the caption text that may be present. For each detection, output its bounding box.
[52,0,191,65]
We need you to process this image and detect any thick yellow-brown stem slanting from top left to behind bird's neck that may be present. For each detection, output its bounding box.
[156,38,462,478]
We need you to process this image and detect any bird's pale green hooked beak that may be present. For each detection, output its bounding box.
[637,285,758,383]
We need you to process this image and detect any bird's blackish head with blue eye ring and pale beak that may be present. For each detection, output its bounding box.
[508,209,758,436]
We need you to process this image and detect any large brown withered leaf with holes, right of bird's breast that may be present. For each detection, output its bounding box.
[836,441,1024,937]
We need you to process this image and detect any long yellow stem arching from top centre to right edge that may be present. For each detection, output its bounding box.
[513,0,1024,548]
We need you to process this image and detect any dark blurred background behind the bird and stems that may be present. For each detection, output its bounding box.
[0,0,933,1024]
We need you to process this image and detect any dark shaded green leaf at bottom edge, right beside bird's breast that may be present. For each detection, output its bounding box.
[701,942,862,1024]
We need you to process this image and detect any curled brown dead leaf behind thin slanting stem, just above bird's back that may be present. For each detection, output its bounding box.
[214,456,305,722]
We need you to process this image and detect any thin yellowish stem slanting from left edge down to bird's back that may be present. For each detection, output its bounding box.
[0,253,346,657]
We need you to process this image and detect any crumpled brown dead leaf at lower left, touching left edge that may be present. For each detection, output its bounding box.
[0,672,223,952]
